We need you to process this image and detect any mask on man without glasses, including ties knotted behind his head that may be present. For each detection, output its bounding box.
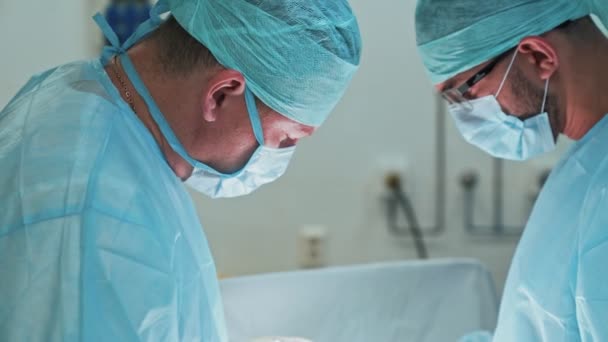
[94,10,295,198]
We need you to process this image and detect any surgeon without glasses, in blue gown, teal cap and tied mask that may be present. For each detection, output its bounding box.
[0,0,361,342]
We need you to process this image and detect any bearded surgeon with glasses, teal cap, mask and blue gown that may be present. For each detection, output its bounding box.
[416,0,608,342]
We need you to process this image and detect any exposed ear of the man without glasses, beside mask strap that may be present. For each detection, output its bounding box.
[203,69,245,122]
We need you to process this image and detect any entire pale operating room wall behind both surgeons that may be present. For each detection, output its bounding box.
[0,0,567,296]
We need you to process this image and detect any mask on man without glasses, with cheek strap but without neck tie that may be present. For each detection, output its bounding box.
[186,90,295,198]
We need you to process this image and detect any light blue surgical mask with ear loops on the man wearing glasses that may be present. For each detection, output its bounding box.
[449,51,555,161]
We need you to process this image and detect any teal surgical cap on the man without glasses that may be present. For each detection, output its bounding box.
[160,0,361,127]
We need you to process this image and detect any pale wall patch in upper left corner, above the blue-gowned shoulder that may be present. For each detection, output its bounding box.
[0,0,102,107]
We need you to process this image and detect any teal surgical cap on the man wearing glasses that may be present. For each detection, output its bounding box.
[416,0,608,84]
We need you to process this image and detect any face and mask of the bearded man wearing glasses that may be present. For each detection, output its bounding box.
[437,22,570,161]
